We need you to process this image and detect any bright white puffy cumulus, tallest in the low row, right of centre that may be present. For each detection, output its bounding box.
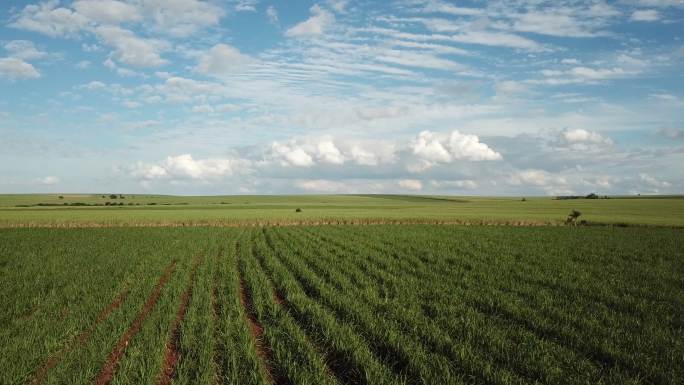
[409,130,502,171]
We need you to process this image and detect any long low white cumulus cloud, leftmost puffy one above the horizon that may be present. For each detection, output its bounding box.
[131,154,249,181]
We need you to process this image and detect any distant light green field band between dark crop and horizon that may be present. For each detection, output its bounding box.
[0,194,684,227]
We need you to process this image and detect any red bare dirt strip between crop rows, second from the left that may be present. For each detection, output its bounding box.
[93,260,176,385]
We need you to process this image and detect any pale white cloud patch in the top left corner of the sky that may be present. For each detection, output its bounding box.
[10,0,88,37]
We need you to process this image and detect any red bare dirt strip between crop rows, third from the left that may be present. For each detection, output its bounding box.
[157,253,203,385]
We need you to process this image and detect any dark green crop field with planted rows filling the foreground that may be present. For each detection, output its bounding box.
[0,225,684,385]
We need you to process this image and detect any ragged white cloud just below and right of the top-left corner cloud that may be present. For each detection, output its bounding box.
[95,26,169,67]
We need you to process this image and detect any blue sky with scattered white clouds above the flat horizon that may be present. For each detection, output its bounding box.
[0,0,684,195]
